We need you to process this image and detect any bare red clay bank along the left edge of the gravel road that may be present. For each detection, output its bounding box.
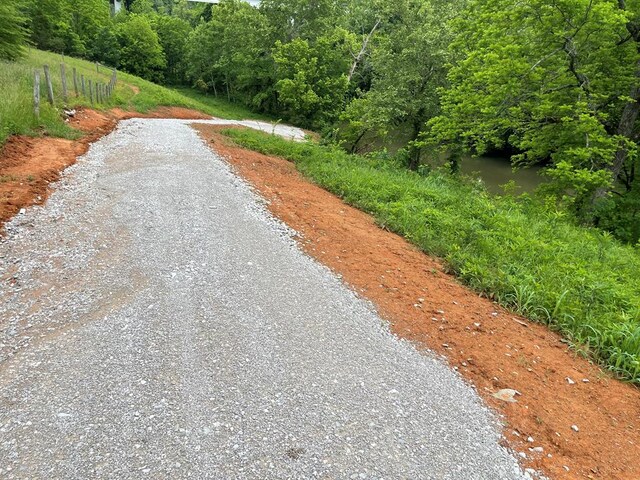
[0,107,211,226]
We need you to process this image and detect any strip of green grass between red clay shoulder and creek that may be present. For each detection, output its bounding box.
[224,129,640,383]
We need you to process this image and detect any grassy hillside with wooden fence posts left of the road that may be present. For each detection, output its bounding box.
[0,49,265,145]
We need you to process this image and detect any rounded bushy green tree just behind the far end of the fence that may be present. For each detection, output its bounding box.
[116,14,167,82]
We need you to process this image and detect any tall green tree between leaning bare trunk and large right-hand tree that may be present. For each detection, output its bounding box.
[342,0,459,169]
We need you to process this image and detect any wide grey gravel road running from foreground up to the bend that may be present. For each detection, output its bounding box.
[0,119,529,480]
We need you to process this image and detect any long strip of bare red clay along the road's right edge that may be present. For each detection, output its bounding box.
[197,125,640,480]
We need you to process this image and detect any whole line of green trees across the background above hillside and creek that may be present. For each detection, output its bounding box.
[0,0,640,243]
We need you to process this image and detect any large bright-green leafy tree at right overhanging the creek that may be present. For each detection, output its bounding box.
[431,0,640,221]
